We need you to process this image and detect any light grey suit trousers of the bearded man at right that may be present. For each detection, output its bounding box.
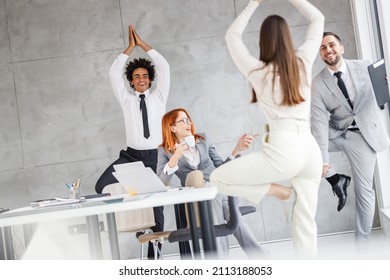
[327,130,376,248]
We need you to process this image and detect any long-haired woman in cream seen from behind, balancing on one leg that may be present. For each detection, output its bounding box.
[210,0,324,253]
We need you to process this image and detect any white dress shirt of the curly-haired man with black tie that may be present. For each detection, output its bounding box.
[109,49,170,150]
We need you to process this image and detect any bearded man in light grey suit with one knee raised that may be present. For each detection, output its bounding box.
[312,32,390,248]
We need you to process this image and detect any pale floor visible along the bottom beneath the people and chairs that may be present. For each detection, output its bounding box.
[164,229,390,260]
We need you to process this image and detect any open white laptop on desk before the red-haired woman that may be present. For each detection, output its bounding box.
[112,167,168,195]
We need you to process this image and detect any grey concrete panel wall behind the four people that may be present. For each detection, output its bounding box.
[0,0,356,257]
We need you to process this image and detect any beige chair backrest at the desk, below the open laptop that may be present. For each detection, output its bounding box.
[102,183,155,232]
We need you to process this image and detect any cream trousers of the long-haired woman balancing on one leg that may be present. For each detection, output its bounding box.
[210,120,322,254]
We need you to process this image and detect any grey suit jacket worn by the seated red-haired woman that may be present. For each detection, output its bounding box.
[156,134,230,186]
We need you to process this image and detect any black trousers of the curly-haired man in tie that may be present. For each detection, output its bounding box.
[95,147,164,259]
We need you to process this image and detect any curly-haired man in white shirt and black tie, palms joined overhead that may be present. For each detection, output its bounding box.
[95,25,170,259]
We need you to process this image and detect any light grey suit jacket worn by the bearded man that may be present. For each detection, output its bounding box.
[311,59,390,163]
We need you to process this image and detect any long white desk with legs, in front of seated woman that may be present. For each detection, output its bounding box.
[0,187,217,259]
